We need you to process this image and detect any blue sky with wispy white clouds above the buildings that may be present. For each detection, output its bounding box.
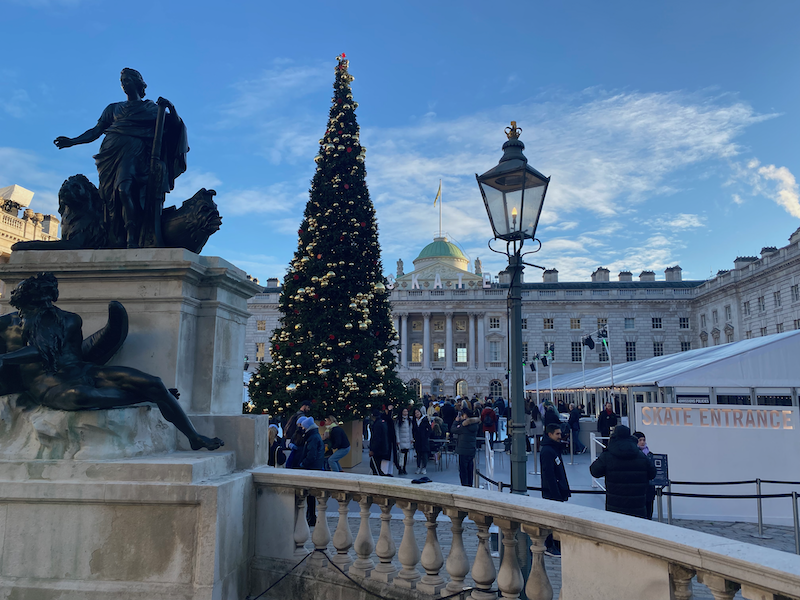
[0,0,800,282]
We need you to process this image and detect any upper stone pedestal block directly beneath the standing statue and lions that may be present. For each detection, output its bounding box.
[0,248,267,469]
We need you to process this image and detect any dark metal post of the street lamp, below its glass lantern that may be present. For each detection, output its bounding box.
[508,251,528,495]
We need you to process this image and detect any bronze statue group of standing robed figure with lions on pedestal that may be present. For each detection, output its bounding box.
[18,68,222,253]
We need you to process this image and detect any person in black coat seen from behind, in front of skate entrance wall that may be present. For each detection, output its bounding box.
[589,425,656,519]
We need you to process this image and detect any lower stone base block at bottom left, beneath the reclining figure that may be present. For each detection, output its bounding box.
[0,452,254,600]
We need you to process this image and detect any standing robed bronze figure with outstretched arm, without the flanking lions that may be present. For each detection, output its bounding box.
[53,68,189,248]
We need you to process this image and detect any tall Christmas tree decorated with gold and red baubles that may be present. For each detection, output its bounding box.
[249,54,410,420]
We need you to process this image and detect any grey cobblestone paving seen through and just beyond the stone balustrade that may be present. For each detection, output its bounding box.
[298,513,795,600]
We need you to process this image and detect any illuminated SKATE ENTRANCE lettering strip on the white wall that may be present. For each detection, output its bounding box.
[638,404,795,429]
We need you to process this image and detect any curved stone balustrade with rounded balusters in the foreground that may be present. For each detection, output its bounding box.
[251,468,800,600]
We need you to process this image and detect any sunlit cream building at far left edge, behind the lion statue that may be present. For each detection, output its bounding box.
[0,185,59,296]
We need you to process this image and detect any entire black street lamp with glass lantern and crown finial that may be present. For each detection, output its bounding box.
[475,121,550,494]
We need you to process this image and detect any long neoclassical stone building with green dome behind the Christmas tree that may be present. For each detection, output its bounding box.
[246,230,800,404]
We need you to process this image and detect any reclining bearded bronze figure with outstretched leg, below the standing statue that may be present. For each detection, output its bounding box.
[0,273,224,450]
